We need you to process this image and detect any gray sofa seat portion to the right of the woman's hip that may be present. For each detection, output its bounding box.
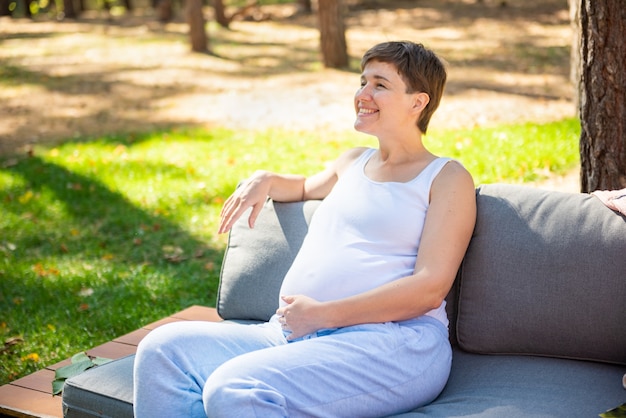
[398,349,626,418]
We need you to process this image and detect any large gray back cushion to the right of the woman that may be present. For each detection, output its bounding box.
[456,185,626,364]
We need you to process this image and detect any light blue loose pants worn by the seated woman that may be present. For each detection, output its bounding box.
[134,317,452,418]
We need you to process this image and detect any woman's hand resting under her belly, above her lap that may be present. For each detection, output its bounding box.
[276,295,324,340]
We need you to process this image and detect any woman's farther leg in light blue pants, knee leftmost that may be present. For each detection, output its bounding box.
[134,322,286,418]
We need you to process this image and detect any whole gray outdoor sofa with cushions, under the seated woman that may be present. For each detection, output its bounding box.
[63,185,626,418]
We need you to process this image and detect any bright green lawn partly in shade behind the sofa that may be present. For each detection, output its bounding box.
[0,120,579,384]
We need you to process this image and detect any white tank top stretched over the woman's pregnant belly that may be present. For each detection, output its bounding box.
[280,149,450,326]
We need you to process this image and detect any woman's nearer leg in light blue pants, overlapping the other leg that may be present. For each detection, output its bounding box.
[203,318,451,418]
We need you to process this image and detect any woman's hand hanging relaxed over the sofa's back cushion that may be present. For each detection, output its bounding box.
[218,171,271,234]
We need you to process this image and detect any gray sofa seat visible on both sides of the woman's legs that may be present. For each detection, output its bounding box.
[63,349,626,418]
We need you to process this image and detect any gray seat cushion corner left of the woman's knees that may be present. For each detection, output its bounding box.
[63,355,135,418]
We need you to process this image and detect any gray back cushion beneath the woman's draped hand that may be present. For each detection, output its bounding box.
[217,200,320,321]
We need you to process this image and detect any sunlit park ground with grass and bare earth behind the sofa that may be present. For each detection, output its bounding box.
[0,0,580,384]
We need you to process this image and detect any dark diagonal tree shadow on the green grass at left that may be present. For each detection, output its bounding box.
[0,157,222,384]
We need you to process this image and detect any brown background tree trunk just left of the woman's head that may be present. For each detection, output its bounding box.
[318,0,348,68]
